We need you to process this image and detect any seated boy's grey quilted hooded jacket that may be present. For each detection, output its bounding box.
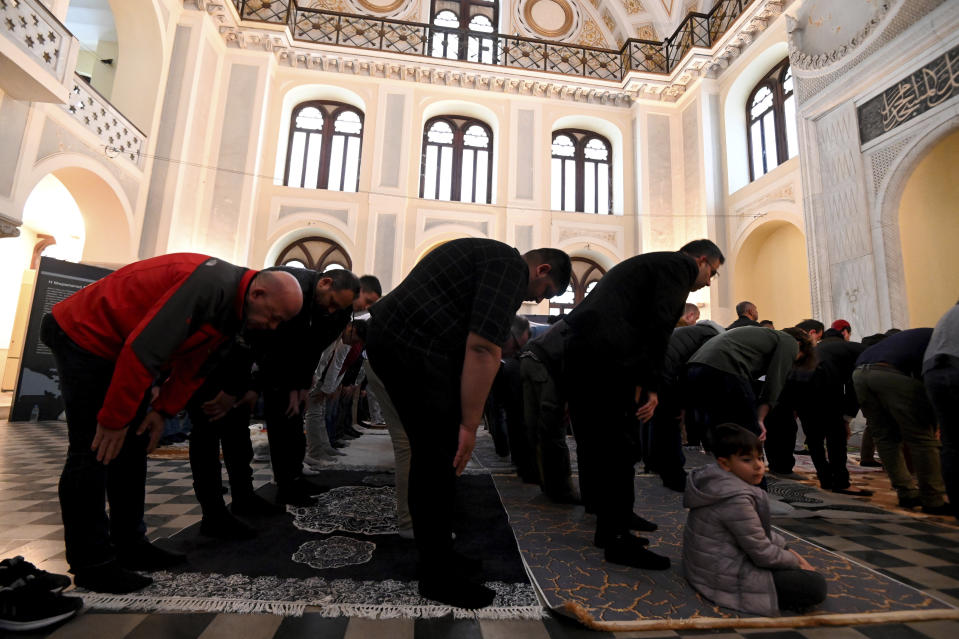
[683,464,799,616]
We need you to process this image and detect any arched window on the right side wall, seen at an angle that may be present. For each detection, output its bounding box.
[746,58,799,181]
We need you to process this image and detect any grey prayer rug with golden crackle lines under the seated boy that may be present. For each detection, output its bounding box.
[495,475,959,631]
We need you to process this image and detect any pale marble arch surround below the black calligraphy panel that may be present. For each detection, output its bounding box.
[870,119,959,328]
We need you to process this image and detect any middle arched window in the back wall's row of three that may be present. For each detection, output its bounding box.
[420,115,493,204]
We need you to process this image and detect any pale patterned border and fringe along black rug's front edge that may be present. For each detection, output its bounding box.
[81,594,546,619]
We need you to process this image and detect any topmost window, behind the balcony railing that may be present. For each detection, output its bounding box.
[430,0,499,64]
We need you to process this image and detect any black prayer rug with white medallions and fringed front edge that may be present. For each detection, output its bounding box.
[84,469,544,619]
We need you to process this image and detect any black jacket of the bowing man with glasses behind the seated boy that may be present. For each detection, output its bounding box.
[566,251,699,390]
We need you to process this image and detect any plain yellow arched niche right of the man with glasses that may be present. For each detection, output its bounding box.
[732,220,812,328]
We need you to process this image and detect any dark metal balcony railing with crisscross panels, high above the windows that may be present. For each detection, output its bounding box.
[233,0,753,80]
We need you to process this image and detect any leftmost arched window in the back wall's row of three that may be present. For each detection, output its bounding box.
[283,100,363,192]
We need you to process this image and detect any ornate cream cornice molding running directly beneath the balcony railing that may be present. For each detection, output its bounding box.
[184,0,792,108]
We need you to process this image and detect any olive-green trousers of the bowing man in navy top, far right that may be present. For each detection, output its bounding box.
[852,364,946,507]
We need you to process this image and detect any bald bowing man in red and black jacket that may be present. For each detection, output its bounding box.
[41,253,303,593]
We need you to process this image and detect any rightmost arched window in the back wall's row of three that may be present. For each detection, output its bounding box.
[550,129,613,213]
